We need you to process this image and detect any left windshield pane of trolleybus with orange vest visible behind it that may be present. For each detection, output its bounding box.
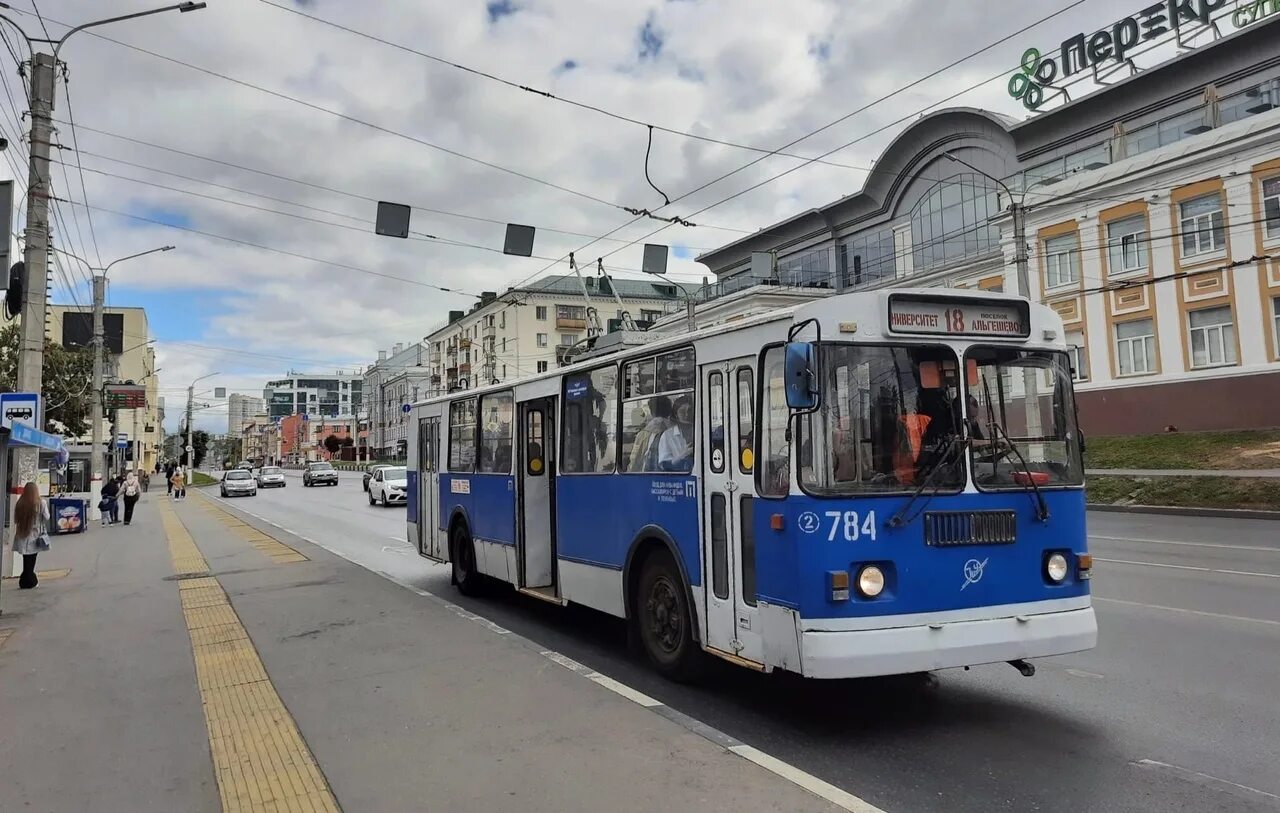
[800,343,965,494]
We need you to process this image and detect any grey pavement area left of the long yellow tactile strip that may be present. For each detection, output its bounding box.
[0,493,219,813]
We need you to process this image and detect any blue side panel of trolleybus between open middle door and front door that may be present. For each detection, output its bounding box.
[556,472,703,585]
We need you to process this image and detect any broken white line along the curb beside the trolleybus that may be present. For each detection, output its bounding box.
[199,497,885,813]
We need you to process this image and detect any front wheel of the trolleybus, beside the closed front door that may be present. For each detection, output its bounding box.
[631,551,707,682]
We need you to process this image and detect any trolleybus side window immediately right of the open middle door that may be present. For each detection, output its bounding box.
[561,365,618,472]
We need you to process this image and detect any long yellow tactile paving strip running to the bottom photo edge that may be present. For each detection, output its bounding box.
[160,506,339,813]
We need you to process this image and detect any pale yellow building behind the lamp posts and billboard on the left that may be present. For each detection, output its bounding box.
[46,305,161,469]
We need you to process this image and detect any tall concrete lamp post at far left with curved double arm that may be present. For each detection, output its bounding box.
[0,3,205,506]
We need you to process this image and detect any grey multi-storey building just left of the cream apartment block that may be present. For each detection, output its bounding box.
[362,342,431,457]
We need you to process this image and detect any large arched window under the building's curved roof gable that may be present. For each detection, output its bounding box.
[911,174,1000,271]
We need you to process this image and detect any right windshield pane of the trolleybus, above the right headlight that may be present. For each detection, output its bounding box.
[965,347,1084,488]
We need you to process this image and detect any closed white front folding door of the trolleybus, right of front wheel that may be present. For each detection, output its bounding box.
[699,357,764,663]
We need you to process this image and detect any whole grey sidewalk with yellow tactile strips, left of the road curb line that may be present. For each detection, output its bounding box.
[0,493,872,813]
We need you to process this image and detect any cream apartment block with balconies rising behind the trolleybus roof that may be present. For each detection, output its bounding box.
[422,274,691,397]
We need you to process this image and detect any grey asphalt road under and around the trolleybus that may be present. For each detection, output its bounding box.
[209,472,1280,813]
